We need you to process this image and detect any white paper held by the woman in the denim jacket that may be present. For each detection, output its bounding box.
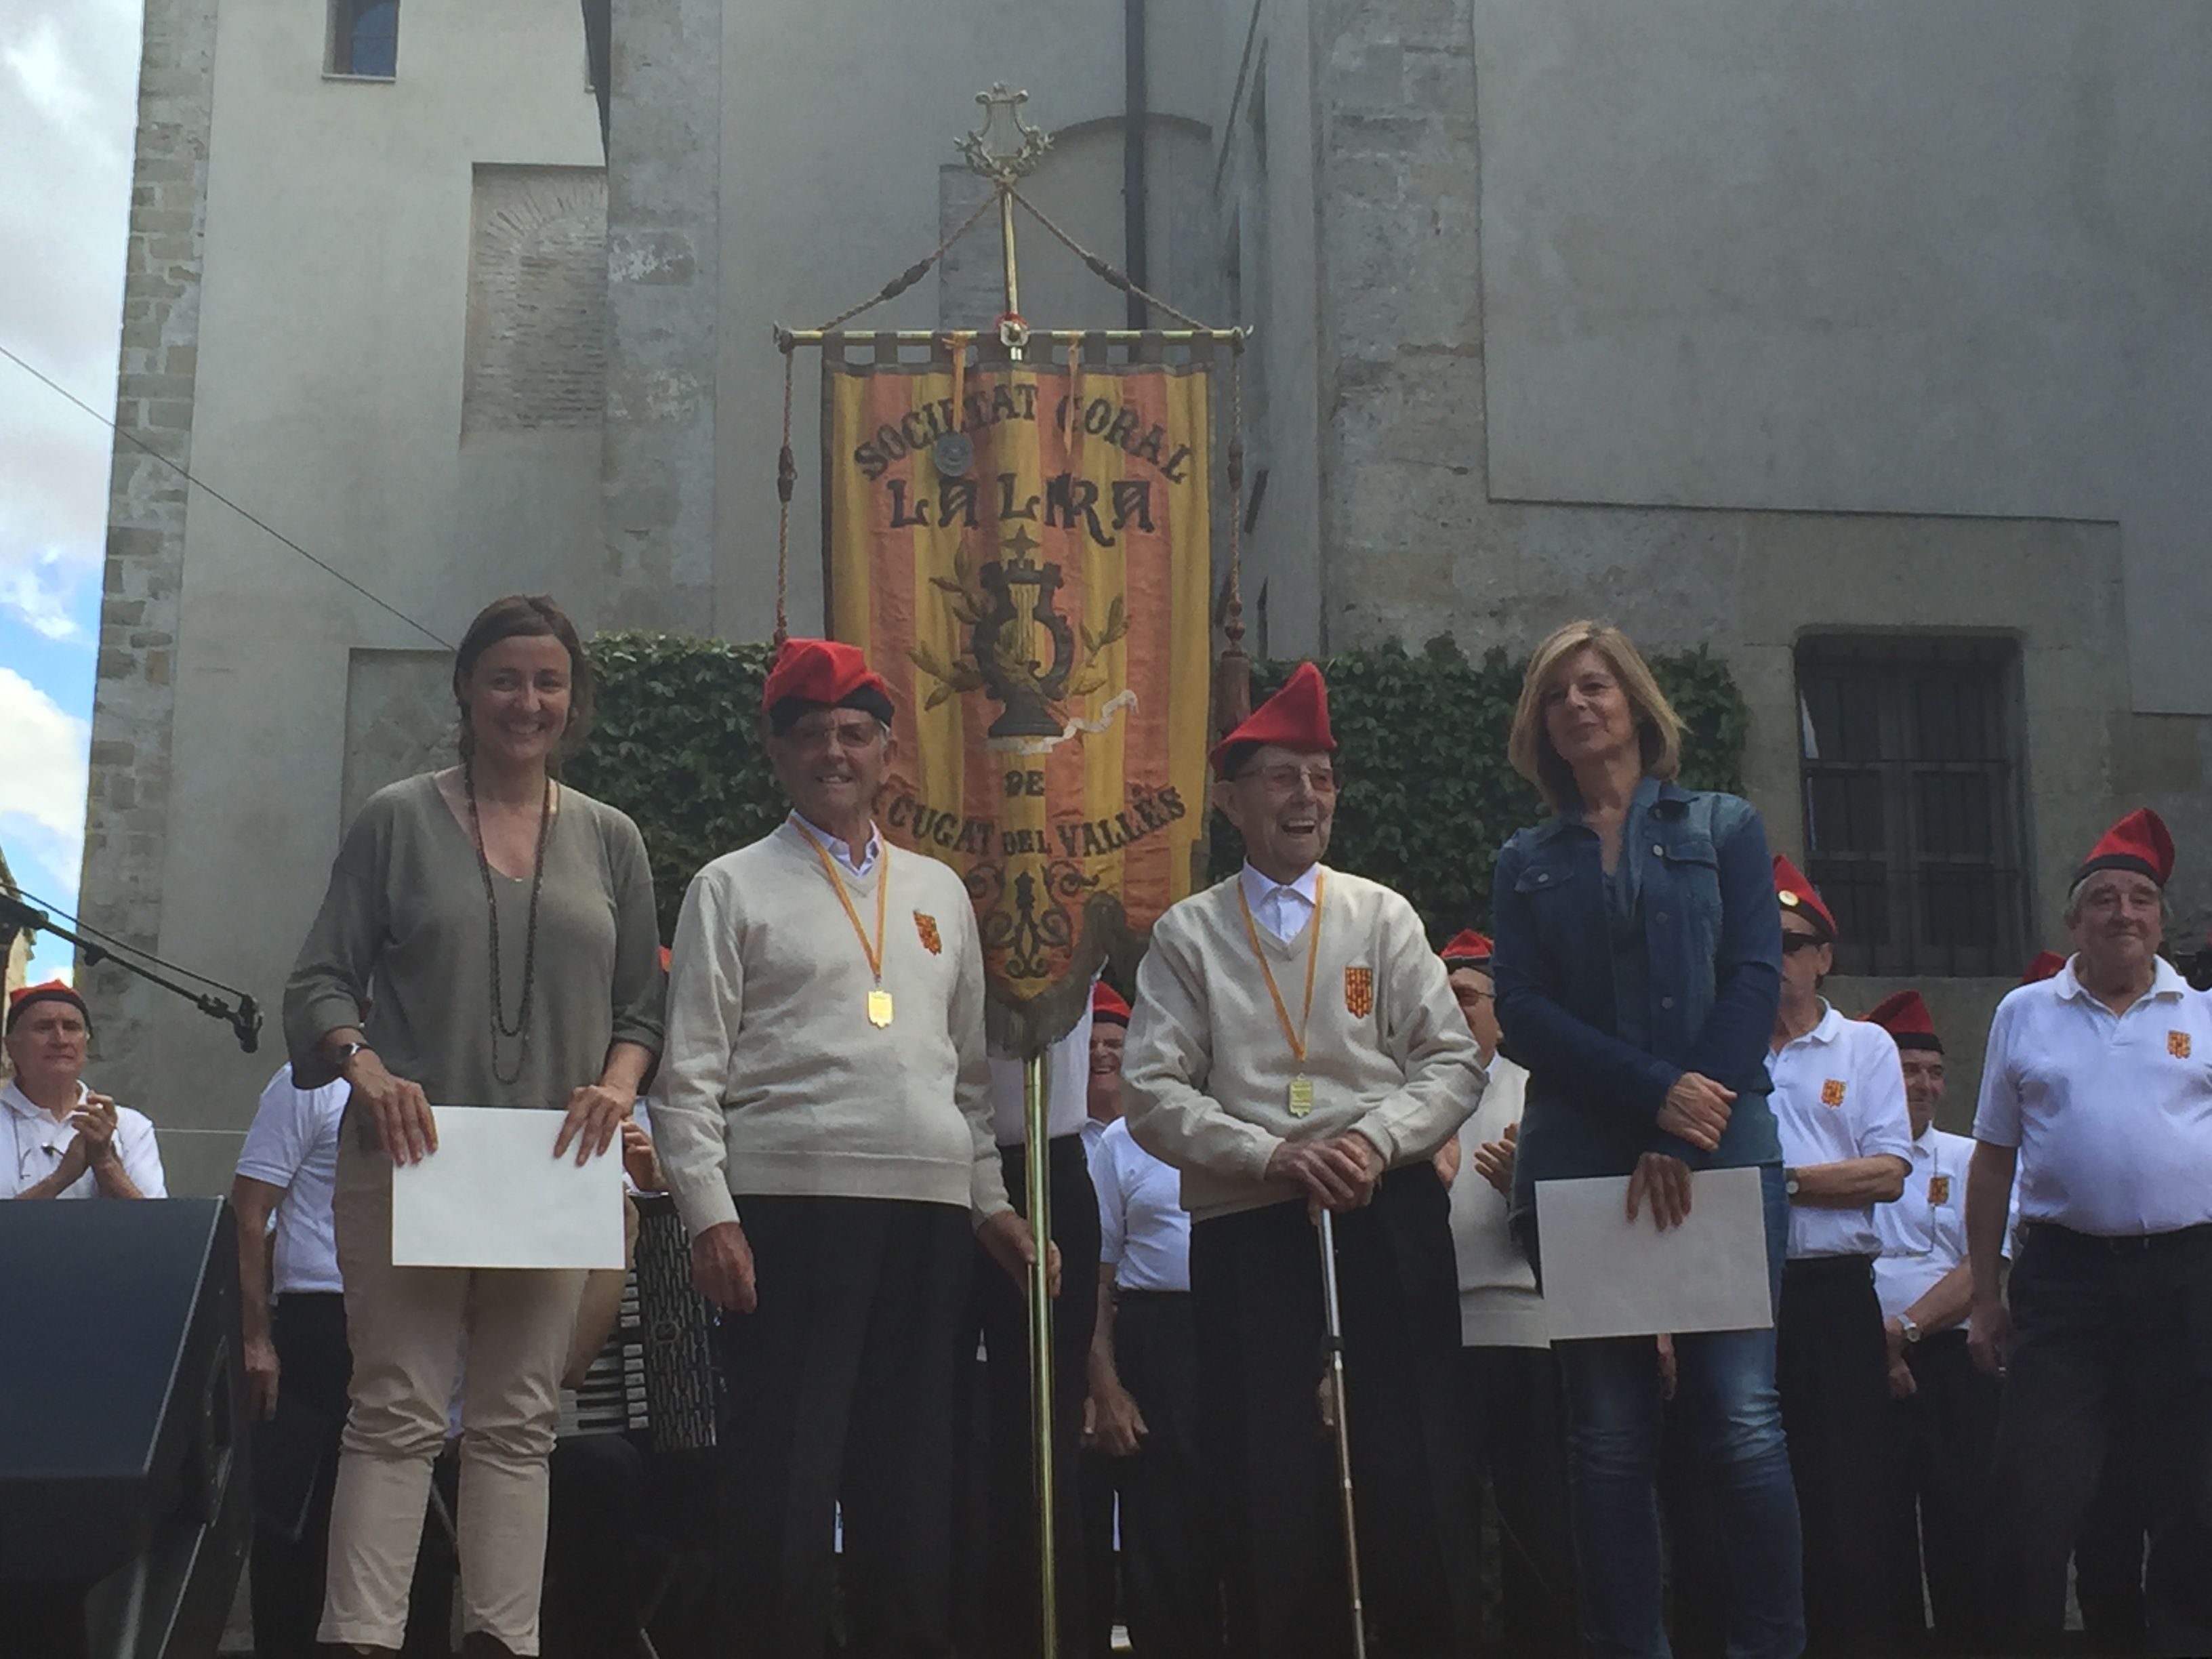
[1535,1170,1774,1343]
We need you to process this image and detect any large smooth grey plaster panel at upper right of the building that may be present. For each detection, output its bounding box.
[1473,0,2212,714]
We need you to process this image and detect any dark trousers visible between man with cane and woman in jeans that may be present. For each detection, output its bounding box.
[1460,1347,1579,1654]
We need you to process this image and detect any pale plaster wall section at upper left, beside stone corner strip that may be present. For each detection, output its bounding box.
[133,0,602,1192]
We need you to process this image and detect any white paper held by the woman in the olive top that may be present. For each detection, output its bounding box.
[392,1106,621,1267]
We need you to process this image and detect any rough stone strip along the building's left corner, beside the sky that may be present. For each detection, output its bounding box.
[80,0,217,1097]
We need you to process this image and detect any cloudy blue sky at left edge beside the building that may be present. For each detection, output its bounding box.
[0,0,142,978]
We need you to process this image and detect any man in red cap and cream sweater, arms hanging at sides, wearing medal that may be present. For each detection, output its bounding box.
[653,639,1052,1659]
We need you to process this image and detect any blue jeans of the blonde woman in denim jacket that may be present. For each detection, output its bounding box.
[1557,1164,1805,1659]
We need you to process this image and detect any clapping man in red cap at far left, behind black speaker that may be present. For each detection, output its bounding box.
[0,980,168,1199]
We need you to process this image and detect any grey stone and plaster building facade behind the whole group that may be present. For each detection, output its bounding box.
[84,0,2212,1190]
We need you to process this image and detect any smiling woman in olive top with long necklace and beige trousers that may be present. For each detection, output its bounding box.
[285,595,661,1654]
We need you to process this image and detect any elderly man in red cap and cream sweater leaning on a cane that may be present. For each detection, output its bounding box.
[1122,663,1482,1659]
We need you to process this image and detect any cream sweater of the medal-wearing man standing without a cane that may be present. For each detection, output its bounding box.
[653,821,1006,1237]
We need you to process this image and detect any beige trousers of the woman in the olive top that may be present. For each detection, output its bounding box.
[316,1113,584,1654]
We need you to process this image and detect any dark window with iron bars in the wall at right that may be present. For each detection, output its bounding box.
[1796,635,2028,975]
